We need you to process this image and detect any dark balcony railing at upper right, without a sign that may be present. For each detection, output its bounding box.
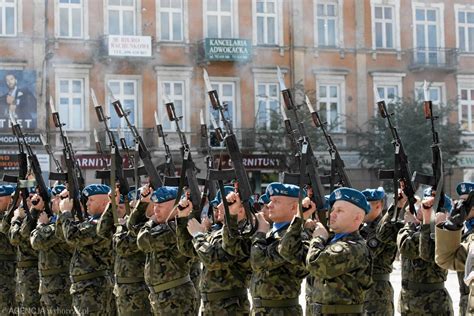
[408,47,458,71]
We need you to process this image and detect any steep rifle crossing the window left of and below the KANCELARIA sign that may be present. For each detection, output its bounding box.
[165,96,201,220]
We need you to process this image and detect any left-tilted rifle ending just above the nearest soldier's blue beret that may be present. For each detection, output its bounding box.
[305,95,352,192]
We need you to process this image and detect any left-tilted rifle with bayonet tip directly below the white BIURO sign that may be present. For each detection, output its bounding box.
[107,85,163,190]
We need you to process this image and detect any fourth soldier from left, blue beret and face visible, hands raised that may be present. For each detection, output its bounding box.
[56,184,115,315]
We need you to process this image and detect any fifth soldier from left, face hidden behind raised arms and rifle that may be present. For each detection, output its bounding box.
[97,190,151,316]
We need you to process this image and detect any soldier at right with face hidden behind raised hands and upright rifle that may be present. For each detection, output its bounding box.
[397,191,453,315]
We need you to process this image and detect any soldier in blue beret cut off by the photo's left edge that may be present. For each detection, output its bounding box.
[0,185,16,315]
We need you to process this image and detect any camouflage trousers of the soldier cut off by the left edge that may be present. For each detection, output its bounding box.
[0,261,15,315]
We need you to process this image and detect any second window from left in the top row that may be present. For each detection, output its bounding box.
[56,0,83,38]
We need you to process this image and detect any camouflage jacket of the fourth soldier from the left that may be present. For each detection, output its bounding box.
[56,212,113,276]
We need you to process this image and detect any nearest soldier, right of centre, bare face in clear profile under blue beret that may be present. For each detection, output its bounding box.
[306,187,372,315]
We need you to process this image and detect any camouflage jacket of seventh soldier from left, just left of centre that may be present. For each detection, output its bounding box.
[177,218,251,293]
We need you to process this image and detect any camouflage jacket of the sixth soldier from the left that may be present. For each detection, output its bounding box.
[136,216,190,286]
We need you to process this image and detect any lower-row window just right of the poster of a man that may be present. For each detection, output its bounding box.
[57,78,85,131]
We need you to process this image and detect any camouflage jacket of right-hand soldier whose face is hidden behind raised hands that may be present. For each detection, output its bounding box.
[397,223,448,285]
